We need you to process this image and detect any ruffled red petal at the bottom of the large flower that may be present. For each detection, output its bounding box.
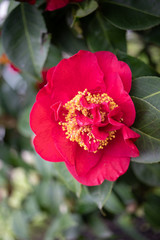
[66,127,139,186]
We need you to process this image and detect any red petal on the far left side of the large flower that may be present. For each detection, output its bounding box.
[30,86,75,164]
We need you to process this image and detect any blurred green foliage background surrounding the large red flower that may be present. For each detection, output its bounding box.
[0,0,160,240]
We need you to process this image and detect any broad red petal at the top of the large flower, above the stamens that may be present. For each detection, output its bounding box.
[52,51,105,103]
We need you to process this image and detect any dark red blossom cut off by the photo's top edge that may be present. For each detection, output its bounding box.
[19,0,83,11]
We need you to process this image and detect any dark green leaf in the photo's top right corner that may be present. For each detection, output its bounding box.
[100,0,160,30]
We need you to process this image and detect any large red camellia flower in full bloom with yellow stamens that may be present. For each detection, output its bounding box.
[30,51,139,186]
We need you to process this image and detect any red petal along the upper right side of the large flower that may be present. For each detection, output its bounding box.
[95,51,136,126]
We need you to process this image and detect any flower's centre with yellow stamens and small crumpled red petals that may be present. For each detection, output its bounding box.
[59,89,120,153]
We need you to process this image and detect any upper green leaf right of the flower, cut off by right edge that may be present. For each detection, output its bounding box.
[130,77,160,110]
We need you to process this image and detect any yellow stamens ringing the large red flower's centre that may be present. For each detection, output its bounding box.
[59,89,118,152]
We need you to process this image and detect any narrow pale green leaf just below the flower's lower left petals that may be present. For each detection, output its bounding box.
[53,162,81,197]
